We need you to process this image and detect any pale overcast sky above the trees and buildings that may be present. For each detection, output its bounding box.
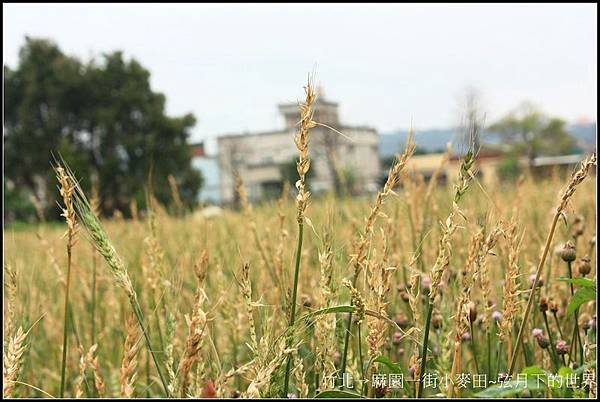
[3,4,597,151]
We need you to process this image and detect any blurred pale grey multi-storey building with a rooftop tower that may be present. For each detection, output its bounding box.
[218,96,379,203]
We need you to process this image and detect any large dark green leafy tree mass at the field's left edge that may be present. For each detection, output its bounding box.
[4,38,202,220]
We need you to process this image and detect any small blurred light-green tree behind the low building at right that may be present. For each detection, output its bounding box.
[490,103,575,164]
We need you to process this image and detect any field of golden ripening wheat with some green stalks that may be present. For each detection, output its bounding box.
[4,85,596,398]
